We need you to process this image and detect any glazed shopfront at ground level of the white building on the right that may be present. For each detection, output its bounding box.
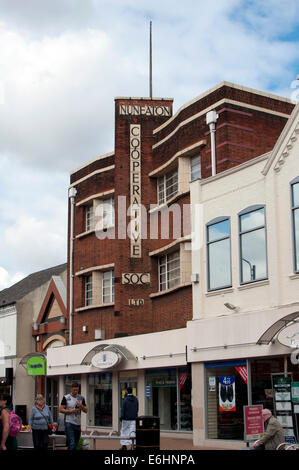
[204,355,299,442]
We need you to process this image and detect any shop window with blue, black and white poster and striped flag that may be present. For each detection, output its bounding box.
[205,361,248,440]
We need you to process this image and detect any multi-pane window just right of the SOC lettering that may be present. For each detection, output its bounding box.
[159,251,181,291]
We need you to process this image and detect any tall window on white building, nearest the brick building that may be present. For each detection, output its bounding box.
[207,219,232,290]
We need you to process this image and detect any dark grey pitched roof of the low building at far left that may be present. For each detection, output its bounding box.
[0,263,67,307]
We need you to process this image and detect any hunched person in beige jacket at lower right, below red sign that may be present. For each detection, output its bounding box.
[253,408,285,450]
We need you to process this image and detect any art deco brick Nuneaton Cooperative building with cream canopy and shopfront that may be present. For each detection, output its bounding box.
[47,82,294,443]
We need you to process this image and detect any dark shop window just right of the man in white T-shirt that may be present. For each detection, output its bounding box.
[87,373,112,427]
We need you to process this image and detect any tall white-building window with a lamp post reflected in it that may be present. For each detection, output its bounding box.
[239,206,268,283]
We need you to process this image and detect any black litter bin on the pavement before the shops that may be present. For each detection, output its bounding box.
[136,416,160,450]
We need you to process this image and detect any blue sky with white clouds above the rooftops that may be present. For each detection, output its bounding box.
[0,0,299,290]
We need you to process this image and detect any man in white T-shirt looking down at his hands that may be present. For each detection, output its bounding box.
[59,382,87,450]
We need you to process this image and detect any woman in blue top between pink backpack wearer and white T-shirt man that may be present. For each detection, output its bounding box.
[29,394,53,450]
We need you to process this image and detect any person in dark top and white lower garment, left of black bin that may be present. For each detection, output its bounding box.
[120,387,138,450]
